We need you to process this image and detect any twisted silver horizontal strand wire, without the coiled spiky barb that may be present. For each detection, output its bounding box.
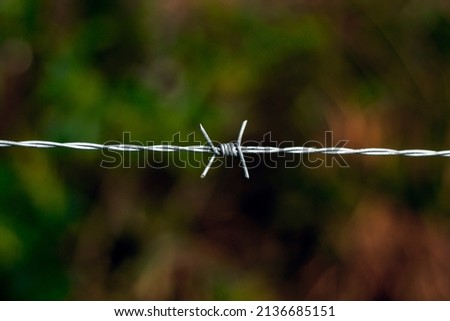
[0,140,450,157]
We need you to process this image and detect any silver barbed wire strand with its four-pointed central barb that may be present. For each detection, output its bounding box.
[0,120,450,178]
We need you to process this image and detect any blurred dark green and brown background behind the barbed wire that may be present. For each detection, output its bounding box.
[0,0,450,300]
